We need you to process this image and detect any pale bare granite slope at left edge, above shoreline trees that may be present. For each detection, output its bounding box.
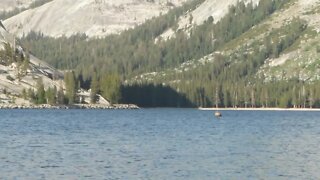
[0,22,64,104]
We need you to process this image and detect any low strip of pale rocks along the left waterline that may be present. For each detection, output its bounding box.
[0,104,140,109]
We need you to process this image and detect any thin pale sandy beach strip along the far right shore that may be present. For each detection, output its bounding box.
[198,108,320,112]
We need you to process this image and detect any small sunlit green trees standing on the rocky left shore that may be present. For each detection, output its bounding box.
[21,71,121,105]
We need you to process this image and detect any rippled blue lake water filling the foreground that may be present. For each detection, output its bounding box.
[0,109,320,180]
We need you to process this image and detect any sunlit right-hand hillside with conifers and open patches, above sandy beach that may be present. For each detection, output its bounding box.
[127,0,320,107]
